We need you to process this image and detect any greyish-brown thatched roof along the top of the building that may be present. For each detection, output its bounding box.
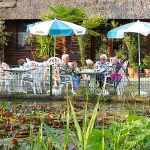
[0,0,150,19]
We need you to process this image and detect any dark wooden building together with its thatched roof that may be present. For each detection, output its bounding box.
[0,0,150,64]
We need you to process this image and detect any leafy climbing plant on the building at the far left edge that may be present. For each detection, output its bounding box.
[0,20,8,62]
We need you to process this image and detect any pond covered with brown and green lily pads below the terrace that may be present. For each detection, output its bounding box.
[0,100,150,147]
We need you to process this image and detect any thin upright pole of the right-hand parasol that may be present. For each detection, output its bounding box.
[138,33,141,96]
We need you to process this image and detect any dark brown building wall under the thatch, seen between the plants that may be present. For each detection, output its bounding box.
[5,20,90,65]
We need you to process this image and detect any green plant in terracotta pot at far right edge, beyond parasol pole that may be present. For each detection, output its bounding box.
[143,56,150,77]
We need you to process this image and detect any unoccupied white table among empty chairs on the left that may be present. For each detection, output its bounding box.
[4,67,36,92]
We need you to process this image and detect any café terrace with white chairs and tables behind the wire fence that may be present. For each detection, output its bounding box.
[0,57,150,97]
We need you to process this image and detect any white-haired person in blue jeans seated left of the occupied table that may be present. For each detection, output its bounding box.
[59,54,80,90]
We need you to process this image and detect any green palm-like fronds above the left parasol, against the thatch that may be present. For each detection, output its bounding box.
[42,4,86,23]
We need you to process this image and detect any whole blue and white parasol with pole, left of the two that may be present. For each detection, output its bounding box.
[27,19,86,57]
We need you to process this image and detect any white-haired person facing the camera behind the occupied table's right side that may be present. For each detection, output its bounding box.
[94,54,109,88]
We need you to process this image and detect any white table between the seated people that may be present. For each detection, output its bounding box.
[79,69,105,88]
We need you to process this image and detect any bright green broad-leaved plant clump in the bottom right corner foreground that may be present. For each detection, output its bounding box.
[105,116,150,150]
